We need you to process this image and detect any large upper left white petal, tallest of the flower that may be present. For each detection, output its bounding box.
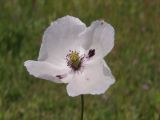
[38,16,86,64]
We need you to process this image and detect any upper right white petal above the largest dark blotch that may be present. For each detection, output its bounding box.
[81,21,114,57]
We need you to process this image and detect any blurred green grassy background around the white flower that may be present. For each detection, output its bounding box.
[0,0,160,120]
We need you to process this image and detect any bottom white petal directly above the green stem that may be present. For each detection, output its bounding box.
[67,61,115,96]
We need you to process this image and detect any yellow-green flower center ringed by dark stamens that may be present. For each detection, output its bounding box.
[66,51,84,71]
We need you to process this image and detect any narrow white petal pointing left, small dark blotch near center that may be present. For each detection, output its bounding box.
[24,60,69,83]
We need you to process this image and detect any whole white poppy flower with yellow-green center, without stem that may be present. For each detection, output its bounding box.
[24,16,115,96]
